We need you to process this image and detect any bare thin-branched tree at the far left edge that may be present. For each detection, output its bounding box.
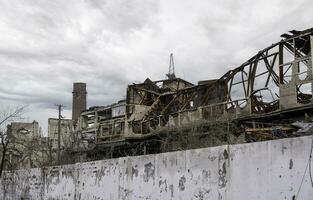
[0,106,25,178]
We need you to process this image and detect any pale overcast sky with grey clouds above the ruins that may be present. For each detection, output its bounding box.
[0,0,313,134]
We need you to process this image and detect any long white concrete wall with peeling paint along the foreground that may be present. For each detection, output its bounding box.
[0,136,313,200]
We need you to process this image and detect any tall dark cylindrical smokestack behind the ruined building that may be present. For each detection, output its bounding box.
[72,83,87,122]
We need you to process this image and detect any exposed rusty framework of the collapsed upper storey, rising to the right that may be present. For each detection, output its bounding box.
[77,29,313,143]
